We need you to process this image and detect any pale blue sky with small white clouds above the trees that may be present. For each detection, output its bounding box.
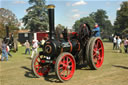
[0,0,126,29]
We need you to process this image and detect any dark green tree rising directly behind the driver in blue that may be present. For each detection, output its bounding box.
[89,9,113,36]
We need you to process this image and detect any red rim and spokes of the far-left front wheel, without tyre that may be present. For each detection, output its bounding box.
[34,55,50,76]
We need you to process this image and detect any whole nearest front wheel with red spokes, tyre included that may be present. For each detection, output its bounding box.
[55,52,76,82]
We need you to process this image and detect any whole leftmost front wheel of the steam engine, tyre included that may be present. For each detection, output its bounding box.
[32,54,50,77]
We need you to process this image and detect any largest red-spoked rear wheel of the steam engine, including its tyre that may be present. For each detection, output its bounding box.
[89,37,104,69]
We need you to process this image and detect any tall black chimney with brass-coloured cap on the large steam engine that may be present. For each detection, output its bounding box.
[48,5,55,39]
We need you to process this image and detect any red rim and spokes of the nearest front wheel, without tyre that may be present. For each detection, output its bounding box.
[58,55,75,80]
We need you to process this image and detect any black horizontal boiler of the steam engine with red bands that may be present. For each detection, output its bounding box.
[43,39,80,56]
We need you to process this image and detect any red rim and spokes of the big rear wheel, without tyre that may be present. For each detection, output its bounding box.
[93,39,104,68]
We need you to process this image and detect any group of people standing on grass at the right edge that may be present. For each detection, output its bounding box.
[113,35,128,53]
